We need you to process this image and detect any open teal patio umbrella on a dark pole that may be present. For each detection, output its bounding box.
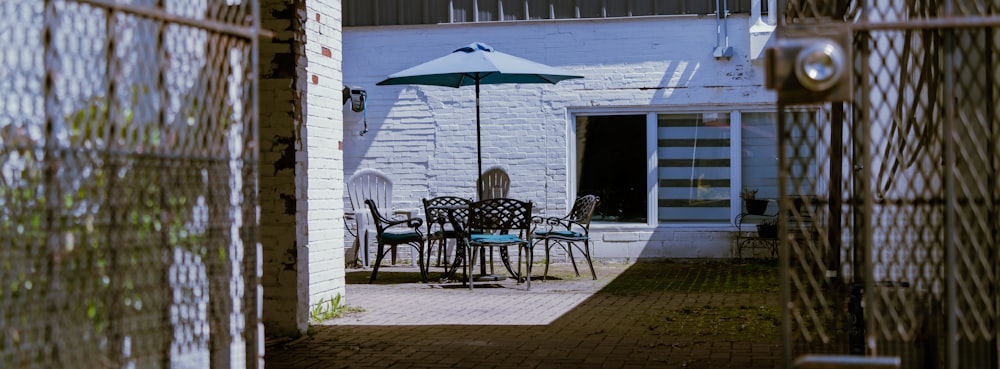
[376,42,583,198]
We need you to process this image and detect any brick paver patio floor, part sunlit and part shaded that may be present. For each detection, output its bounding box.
[265,261,782,369]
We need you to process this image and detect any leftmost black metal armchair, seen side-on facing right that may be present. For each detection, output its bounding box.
[365,199,427,283]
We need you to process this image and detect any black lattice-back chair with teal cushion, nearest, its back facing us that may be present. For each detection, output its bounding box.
[463,198,532,291]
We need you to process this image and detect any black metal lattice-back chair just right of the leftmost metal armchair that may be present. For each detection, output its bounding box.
[422,196,472,275]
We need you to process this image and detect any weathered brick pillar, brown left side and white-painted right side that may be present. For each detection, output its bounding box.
[260,0,346,335]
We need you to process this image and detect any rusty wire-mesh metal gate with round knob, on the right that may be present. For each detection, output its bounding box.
[768,0,1000,369]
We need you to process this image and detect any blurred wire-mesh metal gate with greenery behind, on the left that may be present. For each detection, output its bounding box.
[0,0,262,368]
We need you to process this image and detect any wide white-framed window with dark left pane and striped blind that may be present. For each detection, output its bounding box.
[571,111,778,225]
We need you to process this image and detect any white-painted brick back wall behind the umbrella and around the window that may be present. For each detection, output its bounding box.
[343,15,775,258]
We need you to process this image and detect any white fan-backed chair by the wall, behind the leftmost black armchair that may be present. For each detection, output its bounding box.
[344,169,414,268]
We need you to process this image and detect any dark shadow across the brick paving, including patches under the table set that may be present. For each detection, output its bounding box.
[265,262,781,369]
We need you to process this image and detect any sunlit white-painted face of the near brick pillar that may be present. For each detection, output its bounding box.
[297,0,348,308]
